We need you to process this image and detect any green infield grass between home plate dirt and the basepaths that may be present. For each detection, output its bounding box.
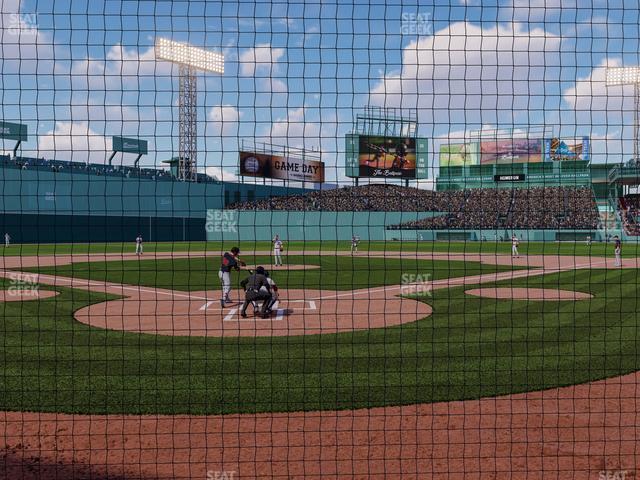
[30,255,522,291]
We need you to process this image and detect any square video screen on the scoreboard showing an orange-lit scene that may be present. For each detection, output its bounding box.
[358,136,416,178]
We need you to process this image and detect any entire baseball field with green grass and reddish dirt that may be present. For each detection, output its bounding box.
[0,242,640,478]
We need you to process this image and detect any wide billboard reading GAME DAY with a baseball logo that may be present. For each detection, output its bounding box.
[240,152,324,183]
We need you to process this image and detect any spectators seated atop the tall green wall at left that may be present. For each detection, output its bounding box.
[0,155,216,183]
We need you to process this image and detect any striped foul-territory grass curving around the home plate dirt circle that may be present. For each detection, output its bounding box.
[0,269,640,414]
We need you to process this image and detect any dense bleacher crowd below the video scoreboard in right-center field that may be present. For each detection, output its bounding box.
[228,184,599,230]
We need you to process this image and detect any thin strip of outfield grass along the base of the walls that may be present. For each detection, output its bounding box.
[0,241,640,257]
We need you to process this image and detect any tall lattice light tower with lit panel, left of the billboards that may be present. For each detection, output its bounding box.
[155,38,224,181]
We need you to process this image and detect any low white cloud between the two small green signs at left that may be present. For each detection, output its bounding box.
[38,122,110,163]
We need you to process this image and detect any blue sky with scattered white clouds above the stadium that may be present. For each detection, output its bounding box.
[0,0,640,185]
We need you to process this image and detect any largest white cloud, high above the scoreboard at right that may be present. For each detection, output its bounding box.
[370,22,561,124]
